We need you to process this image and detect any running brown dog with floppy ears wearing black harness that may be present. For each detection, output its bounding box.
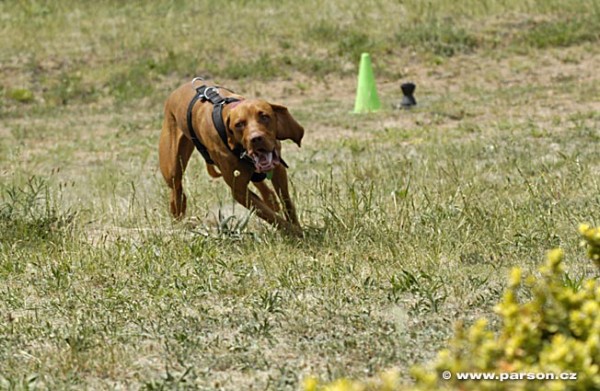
[158,79,304,235]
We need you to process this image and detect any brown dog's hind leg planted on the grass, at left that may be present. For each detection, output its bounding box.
[158,113,194,218]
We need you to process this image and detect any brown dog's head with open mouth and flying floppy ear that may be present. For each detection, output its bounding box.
[225,99,304,172]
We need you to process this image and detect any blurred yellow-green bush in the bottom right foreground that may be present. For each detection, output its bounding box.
[304,225,600,391]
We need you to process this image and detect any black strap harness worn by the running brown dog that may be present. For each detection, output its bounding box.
[187,78,270,182]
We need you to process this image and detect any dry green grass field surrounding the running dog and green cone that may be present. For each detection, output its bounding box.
[0,0,600,390]
